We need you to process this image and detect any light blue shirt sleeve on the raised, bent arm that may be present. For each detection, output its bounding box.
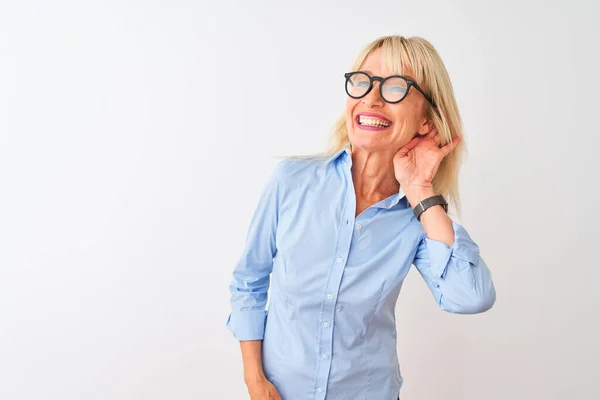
[413,221,496,314]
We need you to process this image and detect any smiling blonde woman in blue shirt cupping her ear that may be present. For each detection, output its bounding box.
[227,36,496,400]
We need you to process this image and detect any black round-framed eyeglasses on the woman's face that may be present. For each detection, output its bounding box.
[344,71,437,108]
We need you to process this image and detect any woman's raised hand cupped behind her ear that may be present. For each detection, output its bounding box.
[393,128,460,193]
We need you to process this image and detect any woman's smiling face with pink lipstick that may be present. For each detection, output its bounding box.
[346,49,432,153]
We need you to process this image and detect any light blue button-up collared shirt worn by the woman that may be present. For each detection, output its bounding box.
[226,146,496,400]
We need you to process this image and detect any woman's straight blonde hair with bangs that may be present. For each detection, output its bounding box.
[278,35,466,214]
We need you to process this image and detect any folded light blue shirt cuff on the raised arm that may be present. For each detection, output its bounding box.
[425,221,479,279]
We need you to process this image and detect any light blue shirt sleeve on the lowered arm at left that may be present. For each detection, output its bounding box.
[226,161,284,341]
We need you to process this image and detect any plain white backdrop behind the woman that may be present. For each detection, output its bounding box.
[0,0,600,400]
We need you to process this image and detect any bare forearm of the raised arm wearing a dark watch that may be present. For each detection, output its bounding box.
[405,184,454,247]
